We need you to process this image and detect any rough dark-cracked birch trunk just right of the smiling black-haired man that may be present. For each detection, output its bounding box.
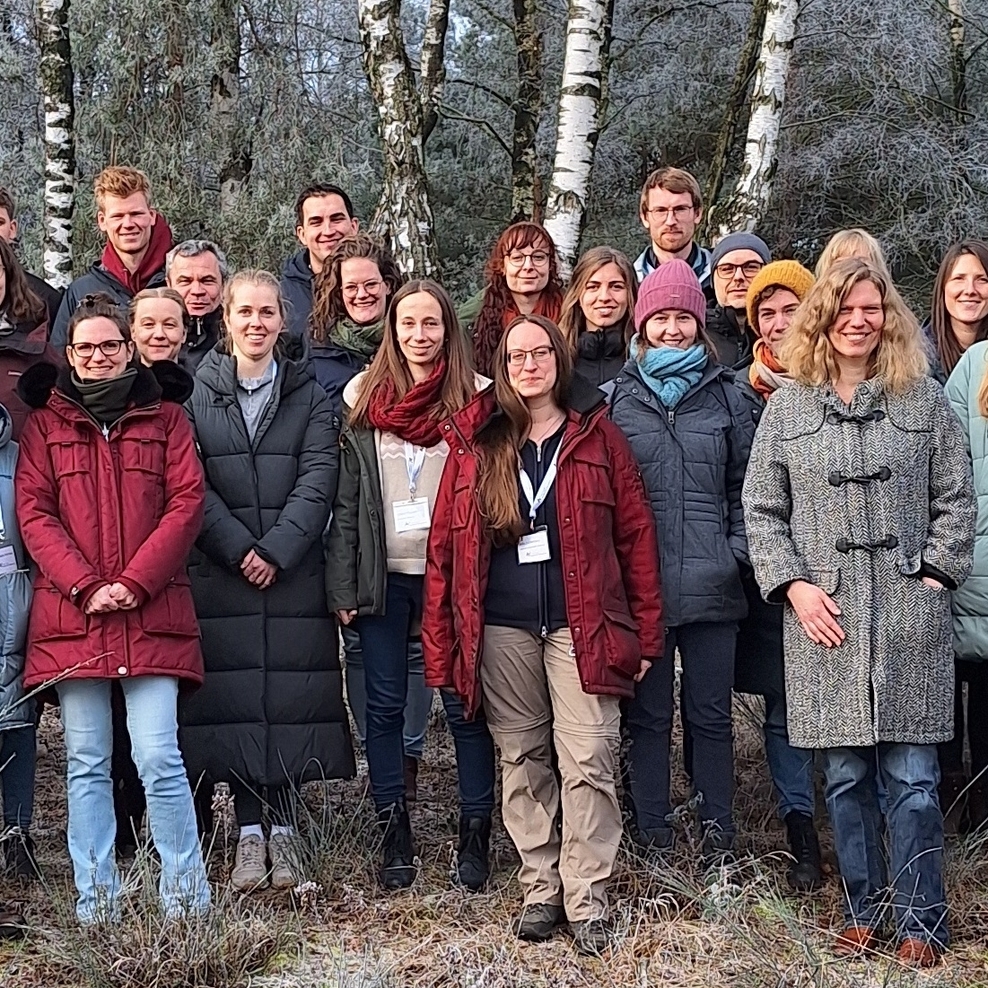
[357,0,439,278]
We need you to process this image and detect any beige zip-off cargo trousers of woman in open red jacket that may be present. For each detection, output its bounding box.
[480,627,621,922]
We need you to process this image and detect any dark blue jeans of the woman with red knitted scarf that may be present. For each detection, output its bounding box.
[357,573,494,816]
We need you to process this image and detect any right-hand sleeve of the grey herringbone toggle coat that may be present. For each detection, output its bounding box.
[921,387,977,590]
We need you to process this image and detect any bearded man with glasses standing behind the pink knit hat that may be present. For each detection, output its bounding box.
[635,168,711,299]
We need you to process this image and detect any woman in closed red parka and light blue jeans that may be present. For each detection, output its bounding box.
[13,294,209,924]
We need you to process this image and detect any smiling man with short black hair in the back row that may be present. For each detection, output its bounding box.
[281,183,360,336]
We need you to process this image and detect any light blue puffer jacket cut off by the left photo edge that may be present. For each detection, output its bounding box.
[0,405,34,731]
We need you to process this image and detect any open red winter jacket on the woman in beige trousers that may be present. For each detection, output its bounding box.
[422,382,663,718]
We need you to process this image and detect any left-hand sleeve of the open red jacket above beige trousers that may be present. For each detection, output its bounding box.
[422,454,460,688]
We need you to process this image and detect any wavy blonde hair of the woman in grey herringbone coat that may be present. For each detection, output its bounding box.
[779,257,929,393]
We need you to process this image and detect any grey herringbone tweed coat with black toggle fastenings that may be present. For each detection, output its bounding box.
[742,378,975,748]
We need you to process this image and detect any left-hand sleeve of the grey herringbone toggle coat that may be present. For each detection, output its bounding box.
[741,397,811,604]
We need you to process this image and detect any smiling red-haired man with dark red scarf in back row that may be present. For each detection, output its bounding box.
[51,165,172,350]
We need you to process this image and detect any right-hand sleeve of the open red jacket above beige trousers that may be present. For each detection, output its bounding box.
[601,419,665,659]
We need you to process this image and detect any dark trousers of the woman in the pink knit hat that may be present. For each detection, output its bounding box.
[628,623,738,834]
